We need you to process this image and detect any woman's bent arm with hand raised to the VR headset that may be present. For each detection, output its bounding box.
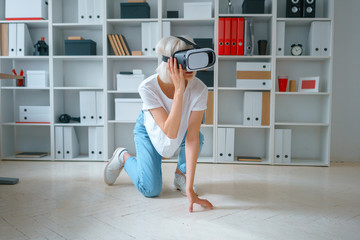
[150,57,185,139]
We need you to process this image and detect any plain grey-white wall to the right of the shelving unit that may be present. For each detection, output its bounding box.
[331,0,360,161]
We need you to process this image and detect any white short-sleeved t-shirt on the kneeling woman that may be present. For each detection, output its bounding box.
[139,74,208,158]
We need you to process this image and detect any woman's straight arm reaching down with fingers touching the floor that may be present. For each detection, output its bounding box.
[185,111,213,212]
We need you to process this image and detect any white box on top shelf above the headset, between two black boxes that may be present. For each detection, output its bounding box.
[184,2,212,19]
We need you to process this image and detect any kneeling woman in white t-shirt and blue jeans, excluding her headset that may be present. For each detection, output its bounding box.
[104,36,213,212]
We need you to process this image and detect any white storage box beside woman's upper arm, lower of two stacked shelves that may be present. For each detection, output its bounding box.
[115,98,143,122]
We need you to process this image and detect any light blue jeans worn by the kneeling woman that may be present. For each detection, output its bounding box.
[125,112,204,197]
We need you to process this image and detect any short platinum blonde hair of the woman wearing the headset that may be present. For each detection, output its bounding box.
[156,36,194,83]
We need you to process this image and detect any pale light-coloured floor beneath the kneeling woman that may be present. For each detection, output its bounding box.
[0,161,360,240]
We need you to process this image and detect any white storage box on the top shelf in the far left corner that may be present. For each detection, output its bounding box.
[5,0,48,20]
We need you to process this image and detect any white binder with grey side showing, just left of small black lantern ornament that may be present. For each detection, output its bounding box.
[16,23,34,56]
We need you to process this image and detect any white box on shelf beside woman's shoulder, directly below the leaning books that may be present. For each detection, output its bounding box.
[116,74,145,92]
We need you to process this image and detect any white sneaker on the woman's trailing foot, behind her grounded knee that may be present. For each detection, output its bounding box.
[104,148,127,185]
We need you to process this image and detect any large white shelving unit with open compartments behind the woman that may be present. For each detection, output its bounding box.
[0,0,334,166]
